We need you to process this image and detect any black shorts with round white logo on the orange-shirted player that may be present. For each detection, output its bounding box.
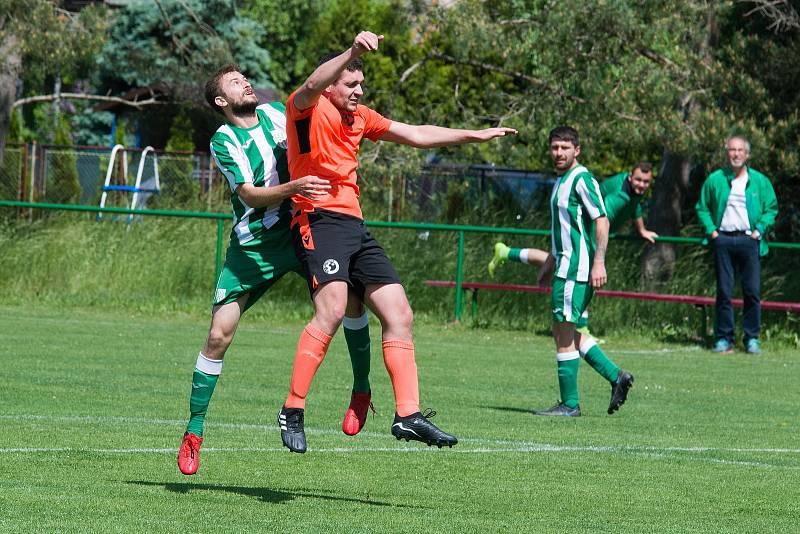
[292,209,400,298]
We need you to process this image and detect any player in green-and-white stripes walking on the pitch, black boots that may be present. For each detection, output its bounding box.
[536,126,633,417]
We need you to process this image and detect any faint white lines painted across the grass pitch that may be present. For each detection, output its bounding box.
[0,414,800,455]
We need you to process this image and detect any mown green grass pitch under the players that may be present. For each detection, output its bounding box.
[0,305,800,532]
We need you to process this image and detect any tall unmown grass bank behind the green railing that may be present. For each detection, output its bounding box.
[0,213,800,345]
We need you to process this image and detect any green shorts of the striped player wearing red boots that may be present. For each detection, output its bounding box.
[213,223,303,310]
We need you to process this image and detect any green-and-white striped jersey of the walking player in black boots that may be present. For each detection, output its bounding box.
[550,165,606,282]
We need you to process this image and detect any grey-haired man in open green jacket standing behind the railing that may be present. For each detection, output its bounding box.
[695,135,778,354]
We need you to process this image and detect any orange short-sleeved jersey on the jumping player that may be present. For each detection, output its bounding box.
[286,91,392,219]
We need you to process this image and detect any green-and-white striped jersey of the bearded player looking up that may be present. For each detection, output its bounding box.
[211,102,290,246]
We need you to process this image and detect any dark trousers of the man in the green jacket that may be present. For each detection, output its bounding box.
[712,234,761,343]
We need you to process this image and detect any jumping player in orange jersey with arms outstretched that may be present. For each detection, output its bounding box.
[278,31,517,452]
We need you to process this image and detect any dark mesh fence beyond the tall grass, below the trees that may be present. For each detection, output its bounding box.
[0,143,553,224]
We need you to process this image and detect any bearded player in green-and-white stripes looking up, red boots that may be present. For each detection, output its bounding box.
[178,65,376,475]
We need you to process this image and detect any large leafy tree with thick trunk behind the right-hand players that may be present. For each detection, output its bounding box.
[409,0,797,279]
